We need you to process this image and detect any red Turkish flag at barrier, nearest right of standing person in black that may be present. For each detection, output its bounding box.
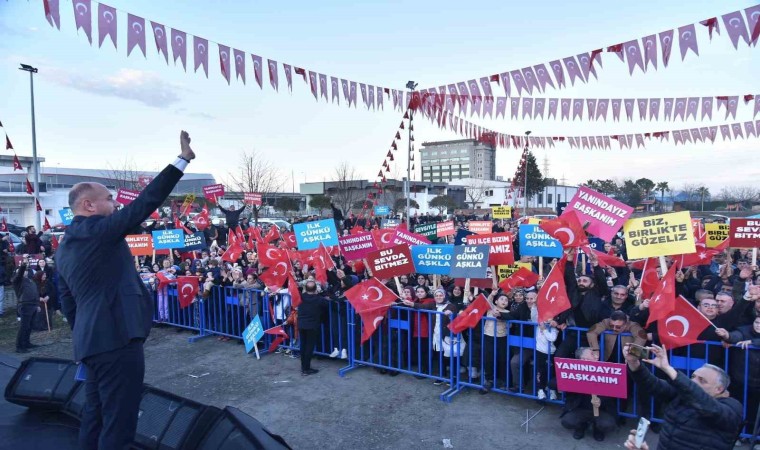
[344,277,398,344]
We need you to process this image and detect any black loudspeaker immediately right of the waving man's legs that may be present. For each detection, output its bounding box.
[132,385,221,450]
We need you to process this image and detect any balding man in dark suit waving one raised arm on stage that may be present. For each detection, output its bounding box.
[55,131,195,449]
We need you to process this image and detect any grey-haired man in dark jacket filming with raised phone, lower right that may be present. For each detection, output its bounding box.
[623,344,742,450]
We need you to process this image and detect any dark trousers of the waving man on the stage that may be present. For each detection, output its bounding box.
[79,339,145,450]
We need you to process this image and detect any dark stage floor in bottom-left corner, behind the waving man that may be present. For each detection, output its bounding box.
[0,353,79,450]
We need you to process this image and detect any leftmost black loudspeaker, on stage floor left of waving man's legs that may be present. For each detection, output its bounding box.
[5,358,81,410]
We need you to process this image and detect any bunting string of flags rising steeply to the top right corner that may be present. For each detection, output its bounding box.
[416,5,760,99]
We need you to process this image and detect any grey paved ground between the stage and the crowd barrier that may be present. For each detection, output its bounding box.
[0,314,656,449]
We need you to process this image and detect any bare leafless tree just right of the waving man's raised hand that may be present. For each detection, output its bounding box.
[226,150,283,225]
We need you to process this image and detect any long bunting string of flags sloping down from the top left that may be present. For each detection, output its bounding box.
[42,0,405,111]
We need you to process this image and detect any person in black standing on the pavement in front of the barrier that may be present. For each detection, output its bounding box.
[298,280,329,376]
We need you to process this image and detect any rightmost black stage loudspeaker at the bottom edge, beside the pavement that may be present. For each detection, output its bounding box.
[196,406,290,450]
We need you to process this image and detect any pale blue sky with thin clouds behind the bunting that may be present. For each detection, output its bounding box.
[0,0,760,193]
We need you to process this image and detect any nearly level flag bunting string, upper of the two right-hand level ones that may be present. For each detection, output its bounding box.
[400,92,760,122]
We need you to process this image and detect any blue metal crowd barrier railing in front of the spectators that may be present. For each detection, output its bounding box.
[154,287,760,437]
